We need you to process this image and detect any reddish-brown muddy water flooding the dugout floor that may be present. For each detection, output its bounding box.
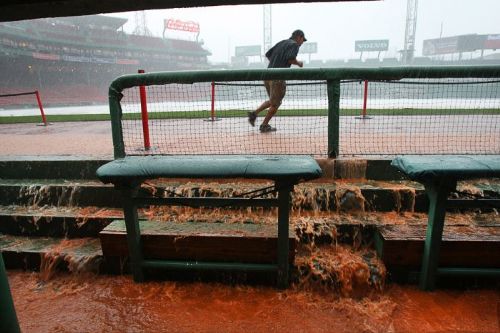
[9,271,500,332]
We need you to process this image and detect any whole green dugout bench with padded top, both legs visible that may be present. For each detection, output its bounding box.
[97,155,322,288]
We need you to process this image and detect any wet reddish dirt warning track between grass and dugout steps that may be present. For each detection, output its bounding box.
[0,116,500,158]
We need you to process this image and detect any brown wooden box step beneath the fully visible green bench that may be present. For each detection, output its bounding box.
[99,220,296,263]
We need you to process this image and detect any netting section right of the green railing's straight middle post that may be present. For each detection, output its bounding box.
[340,78,500,155]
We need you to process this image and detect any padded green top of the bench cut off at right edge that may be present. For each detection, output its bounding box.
[391,155,500,182]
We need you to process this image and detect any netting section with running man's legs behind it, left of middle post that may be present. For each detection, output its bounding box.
[121,81,328,156]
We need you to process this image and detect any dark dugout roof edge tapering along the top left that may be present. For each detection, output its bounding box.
[0,0,376,22]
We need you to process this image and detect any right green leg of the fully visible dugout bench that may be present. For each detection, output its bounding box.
[276,184,293,288]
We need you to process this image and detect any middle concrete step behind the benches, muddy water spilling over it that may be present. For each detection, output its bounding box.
[0,201,500,244]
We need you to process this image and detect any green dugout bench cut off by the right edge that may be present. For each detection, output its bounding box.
[391,155,500,290]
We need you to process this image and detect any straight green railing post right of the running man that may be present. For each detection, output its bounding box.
[326,80,340,158]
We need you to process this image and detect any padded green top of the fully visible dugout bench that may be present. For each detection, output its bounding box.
[97,155,322,183]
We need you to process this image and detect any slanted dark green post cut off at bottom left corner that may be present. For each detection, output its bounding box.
[0,253,21,332]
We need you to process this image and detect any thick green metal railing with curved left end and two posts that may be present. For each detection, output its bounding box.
[109,66,500,158]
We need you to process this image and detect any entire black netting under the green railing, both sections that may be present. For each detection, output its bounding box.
[121,78,500,157]
